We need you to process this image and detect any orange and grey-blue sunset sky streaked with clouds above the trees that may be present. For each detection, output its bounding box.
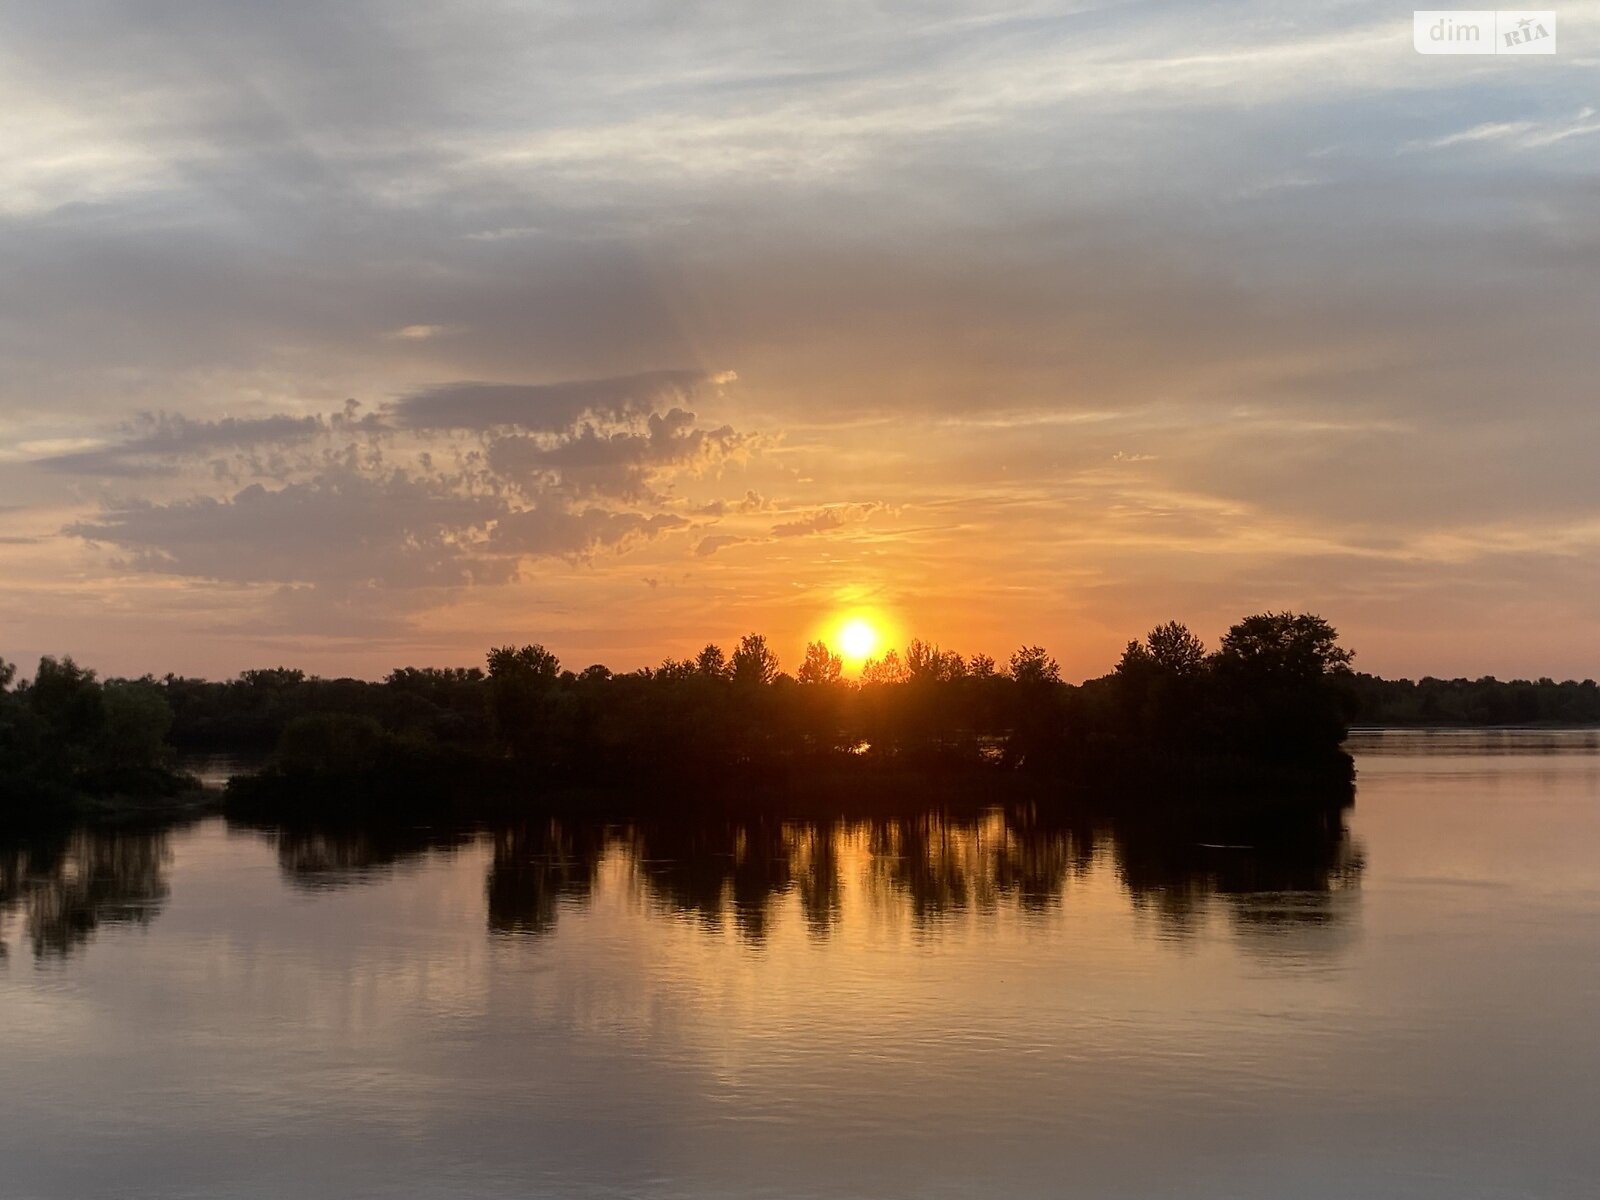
[0,0,1600,680]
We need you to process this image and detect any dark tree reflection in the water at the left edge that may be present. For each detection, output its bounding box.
[0,829,171,957]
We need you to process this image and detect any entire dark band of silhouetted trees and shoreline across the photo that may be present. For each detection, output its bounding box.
[0,613,1600,821]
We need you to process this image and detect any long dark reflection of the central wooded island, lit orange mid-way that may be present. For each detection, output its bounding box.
[232,806,1363,944]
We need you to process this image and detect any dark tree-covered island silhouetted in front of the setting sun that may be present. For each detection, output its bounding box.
[225,613,1352,808]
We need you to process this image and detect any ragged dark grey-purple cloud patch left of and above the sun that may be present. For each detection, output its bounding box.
[53,371,760,619]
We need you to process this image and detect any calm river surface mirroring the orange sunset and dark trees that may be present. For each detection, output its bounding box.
[0,733,1600,1200]
